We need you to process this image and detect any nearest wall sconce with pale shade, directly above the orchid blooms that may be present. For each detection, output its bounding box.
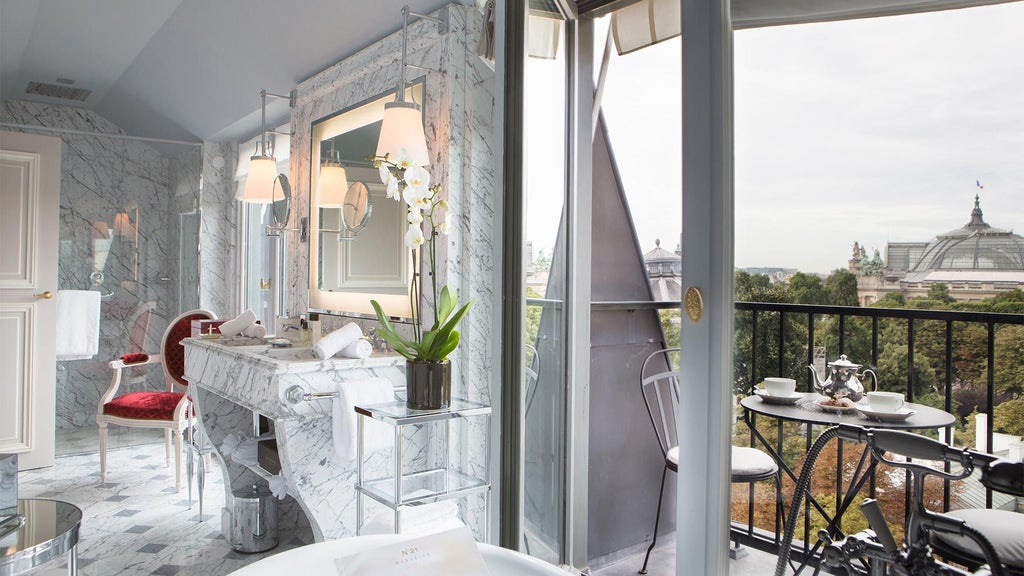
[377,4,447,166]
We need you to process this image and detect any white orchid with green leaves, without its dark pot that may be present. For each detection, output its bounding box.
[370,150,473,362]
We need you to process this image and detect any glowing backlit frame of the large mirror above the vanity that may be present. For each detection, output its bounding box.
[308,80,425,323]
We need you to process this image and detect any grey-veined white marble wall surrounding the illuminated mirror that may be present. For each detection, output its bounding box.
[286,4,501,537]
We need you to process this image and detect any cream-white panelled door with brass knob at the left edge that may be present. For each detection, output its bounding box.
[0,132,60,469]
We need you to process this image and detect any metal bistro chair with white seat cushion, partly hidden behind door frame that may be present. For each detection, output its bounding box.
[640,348,779,574]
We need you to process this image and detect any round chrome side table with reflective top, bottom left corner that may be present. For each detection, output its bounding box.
[0,498,82,576]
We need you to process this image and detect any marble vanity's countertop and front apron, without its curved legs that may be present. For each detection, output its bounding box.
[182,338,406,418]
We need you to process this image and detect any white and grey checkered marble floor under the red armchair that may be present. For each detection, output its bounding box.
[18,443,312,576]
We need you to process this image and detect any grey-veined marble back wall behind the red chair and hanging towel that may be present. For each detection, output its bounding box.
[0,100,202,427]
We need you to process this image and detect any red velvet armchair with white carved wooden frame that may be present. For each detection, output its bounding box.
[96,310,217,490]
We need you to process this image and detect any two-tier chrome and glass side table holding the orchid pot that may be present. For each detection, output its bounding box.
[355,399,490,535]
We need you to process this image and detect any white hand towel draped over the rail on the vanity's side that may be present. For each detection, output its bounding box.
[331,378,394,465]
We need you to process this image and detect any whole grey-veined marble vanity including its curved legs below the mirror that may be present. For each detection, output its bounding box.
[182,338,406,541]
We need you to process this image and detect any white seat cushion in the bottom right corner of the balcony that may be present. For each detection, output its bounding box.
[932,508,1024,571]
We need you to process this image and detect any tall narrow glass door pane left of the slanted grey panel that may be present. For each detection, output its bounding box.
[521,12,569,564]
